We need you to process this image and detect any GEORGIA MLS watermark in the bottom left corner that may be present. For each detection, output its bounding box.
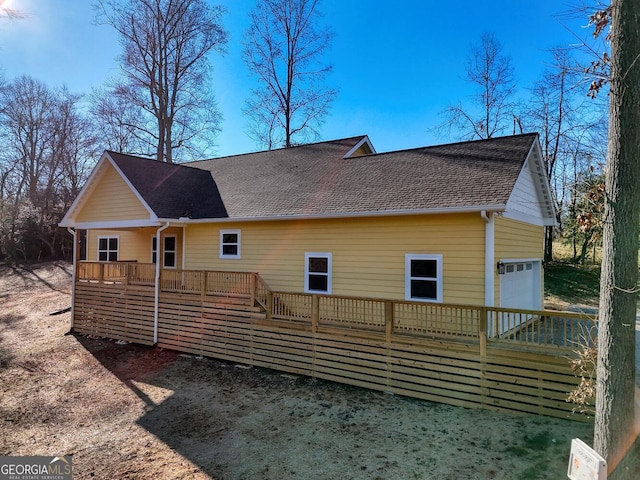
[0,456,73,480]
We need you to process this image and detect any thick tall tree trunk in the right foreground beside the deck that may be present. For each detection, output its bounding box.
[594,0,640,478]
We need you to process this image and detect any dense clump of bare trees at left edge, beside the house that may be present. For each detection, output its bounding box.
[0,76,95,259]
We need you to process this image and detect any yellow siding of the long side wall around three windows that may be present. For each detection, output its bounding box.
[186,214,484,304]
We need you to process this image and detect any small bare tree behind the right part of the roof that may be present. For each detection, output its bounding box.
[439,33,518,139]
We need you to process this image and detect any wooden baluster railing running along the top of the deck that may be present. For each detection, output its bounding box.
[76,262,597,351]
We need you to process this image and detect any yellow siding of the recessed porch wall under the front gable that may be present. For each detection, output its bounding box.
[87,227,182,268]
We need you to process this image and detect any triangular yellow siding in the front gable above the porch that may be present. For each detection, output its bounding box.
[75,165,149,222]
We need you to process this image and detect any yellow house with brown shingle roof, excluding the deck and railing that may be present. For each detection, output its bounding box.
[60,134,555,309]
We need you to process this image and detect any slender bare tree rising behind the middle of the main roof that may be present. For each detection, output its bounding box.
[244,0,336,148]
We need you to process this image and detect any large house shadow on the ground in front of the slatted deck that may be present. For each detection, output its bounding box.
[72,335,591,480]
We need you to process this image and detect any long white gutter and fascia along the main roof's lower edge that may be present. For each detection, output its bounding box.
[172,205,505,225]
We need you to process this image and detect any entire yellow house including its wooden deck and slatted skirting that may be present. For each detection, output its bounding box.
[55,134,595,417]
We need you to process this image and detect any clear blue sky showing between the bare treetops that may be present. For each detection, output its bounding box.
[0,0,588,155]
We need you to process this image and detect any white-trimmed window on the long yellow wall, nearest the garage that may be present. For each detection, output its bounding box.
[405,253,442,303]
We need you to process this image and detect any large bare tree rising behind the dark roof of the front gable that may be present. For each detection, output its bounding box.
[97,0,227,162]
